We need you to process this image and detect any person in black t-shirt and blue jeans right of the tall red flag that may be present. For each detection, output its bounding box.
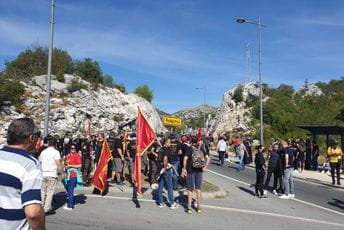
[157,138,177,209]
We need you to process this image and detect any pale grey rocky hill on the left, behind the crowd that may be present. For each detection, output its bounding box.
[0,75,165,144]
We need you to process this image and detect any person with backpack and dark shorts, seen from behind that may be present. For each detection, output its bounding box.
[182,139,210,214]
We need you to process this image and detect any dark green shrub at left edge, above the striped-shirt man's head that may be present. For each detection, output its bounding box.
[0,78,25,106]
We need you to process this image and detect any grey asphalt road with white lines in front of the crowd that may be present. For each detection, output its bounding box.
[47,156,344,230]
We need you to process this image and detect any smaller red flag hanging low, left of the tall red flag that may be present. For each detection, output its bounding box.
[92,139,112,192]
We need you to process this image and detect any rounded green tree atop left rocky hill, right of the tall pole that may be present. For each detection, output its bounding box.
[75,58,103,84]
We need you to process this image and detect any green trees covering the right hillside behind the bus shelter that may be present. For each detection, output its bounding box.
[247,80,344,141]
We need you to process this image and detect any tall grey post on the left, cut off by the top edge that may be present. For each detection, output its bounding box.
[43,0,55,137]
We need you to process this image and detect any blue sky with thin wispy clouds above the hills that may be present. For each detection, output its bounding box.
[0,0,344,112]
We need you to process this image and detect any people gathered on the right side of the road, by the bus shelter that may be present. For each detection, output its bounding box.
[217,136,343,199]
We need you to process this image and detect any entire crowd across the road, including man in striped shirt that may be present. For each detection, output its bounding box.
[0,118,343,229]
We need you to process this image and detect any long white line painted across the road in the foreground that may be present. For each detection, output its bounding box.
[84,194,344,227]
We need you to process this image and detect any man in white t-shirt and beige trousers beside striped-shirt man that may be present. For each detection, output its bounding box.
[39,135,62,212]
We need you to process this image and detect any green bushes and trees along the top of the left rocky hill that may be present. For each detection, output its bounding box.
[0,46,153,106]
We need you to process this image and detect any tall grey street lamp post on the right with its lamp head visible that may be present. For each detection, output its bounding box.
[236,17,266,145]
